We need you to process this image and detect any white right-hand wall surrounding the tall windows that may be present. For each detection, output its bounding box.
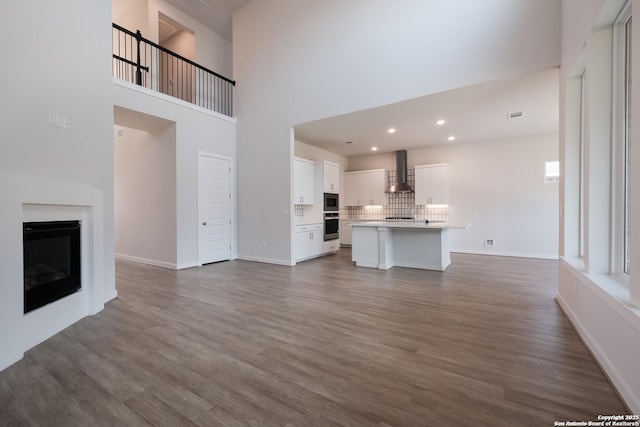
[557,0,640,413]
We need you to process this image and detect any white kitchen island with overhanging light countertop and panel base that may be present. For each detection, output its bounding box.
[351,221,471,271]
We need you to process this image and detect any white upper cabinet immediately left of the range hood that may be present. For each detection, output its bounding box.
[344,169,387,206]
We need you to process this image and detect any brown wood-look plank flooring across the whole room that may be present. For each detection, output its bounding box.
[0,249,626,427]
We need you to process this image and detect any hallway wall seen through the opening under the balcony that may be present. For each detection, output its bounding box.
[114,121,177,268]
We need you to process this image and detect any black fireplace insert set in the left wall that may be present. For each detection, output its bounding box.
[23,221,82,314]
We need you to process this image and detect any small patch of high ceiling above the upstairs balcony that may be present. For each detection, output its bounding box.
[169,0,251,40]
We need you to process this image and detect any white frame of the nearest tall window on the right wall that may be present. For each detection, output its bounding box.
[611,2,632,286]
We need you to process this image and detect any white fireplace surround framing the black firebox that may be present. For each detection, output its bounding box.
[0,177,116,370]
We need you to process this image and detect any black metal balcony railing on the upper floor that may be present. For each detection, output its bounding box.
[112,23,236,117]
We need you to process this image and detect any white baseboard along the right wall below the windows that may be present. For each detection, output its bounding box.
[556,293,640,414]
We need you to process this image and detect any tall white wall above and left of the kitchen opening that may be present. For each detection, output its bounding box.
[233,0,560,263]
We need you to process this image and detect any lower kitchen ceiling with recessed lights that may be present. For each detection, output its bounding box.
[294,69,559,157]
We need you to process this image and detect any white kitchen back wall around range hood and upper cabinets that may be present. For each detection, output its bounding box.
[349,133,558,258]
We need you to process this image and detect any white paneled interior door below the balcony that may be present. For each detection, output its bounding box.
[198,153,231,264]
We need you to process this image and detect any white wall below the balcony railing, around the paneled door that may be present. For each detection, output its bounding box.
[113,82,236,268]
